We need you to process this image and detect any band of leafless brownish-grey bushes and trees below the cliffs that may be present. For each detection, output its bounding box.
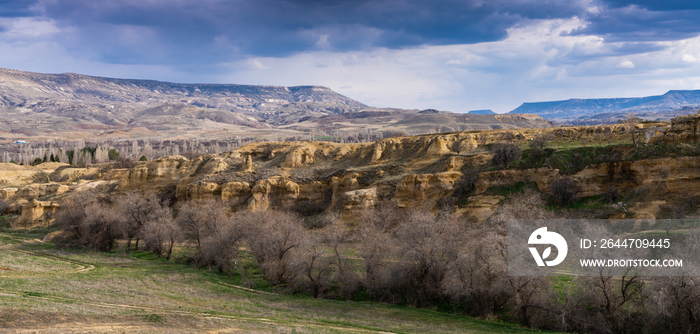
[42,187,700,333]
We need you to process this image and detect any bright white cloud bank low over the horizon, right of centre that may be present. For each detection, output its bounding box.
[217,18,700,112]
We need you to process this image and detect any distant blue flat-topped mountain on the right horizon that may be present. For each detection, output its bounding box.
[509,90,700,120]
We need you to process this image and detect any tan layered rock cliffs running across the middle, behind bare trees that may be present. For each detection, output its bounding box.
[6,117,700,226]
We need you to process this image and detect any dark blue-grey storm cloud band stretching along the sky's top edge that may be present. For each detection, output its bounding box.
[0,0,700,65]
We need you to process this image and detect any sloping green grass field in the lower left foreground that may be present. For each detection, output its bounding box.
[0,231,552,333]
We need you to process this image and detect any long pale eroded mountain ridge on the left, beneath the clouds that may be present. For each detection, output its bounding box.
[0,68,551,141]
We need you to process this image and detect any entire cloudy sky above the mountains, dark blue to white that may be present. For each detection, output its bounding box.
[0,0,700,112]
